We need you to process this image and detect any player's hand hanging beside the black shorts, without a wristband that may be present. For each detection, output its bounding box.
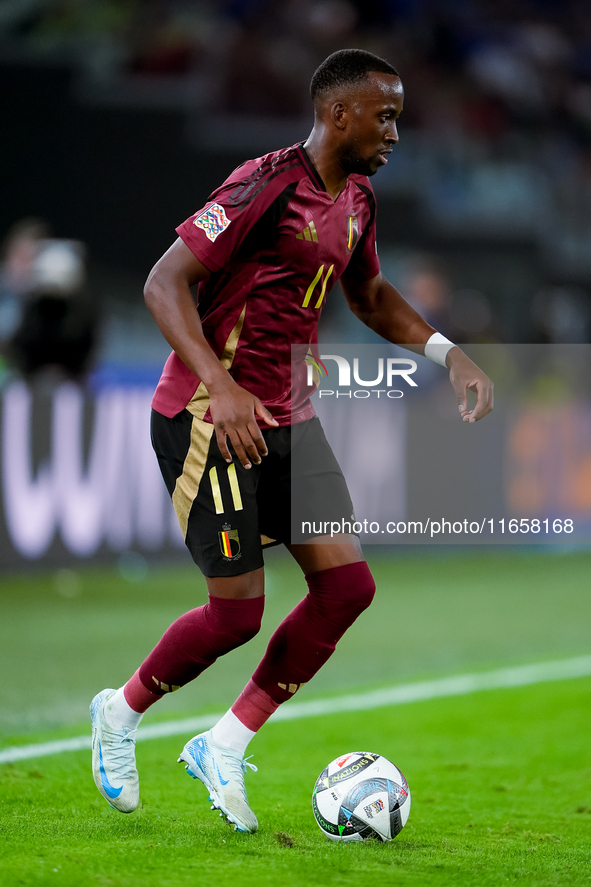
[209,382,279,468]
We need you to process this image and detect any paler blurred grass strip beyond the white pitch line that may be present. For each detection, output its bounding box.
[0,547,591,745]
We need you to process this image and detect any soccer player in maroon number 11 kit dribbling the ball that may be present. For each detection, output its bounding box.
[91,49,492,832]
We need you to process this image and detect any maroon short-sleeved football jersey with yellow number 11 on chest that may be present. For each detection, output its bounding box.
[152,145,380,425]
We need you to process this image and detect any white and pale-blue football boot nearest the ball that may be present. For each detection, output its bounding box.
[178,730,259,833]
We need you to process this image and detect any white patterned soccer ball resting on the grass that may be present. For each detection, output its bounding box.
[312,752,410,841]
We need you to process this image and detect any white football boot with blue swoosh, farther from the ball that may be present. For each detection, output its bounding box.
[90,690,140,813]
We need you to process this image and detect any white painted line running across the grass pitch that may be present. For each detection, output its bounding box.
[0,656,591,764]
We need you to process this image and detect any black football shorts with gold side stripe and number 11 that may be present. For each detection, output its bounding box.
[152,410,353,577]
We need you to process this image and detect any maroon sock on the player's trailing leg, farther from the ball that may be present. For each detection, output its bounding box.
[138,594,265,708]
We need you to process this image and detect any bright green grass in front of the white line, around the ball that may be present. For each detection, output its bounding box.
[0,679,591,887]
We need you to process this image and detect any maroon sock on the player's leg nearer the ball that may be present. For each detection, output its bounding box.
[250,561,375,712]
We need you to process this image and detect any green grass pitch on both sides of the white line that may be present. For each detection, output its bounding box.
[0,549,591,887]
